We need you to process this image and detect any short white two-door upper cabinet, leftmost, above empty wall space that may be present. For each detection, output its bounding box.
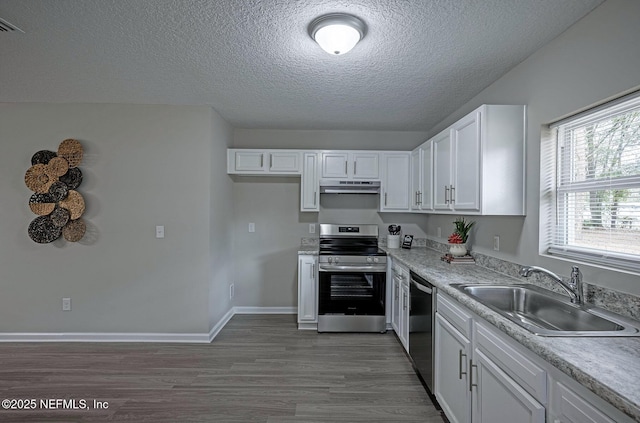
[227,149,302,176]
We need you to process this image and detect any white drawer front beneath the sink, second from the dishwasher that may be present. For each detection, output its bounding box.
[475,322,547,404]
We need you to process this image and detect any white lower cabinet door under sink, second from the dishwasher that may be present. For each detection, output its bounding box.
[470,349,545,423]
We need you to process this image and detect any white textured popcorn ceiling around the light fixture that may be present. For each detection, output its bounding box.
[0,0,602,130]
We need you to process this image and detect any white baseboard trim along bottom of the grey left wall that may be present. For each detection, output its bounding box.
[0,307,298,344]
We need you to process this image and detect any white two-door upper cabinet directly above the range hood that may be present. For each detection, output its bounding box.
[321,151,380,180]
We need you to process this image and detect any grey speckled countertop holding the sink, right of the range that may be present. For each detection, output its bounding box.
[384,248,640,421]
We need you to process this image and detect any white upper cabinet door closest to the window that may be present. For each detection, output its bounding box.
[449,111,481,211]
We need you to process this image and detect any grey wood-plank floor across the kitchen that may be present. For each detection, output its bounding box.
[0,315,444,423]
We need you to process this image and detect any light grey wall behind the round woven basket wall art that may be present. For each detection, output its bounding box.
[0,104,232,333]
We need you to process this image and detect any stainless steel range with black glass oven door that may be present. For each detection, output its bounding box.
[318,224,387,332]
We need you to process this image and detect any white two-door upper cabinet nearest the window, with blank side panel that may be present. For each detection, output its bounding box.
[431,105,525,215]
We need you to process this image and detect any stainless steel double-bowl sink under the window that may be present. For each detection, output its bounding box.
[451,284,640,336]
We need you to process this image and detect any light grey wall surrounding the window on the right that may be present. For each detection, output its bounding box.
[428,0,640,295]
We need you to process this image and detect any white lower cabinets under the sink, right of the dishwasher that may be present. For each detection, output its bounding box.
[434,292,633,423]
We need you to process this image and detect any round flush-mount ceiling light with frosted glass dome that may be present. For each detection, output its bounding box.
[309,13,367,55]
